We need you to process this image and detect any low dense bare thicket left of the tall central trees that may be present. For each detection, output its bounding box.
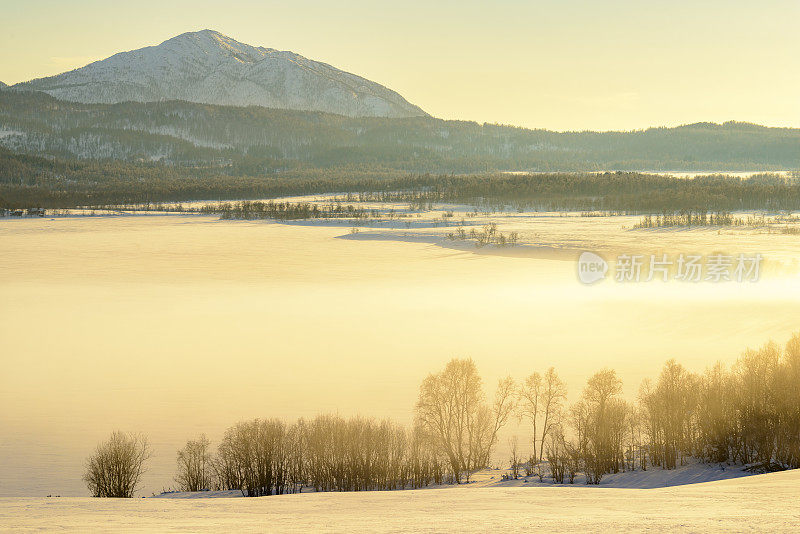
[175,415,446,497]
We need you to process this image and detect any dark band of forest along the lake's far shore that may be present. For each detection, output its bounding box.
[0,149,800,220]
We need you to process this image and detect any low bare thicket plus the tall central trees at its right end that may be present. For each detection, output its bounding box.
[175,359,515,496]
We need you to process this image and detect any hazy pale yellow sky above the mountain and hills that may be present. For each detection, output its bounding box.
[0,0,800,130]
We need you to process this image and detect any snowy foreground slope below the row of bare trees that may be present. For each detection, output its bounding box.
[0,470,800,532]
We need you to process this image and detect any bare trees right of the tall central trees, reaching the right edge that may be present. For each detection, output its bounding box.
[513,334,800,484]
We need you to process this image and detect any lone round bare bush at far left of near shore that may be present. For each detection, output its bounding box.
[83,431,150,498]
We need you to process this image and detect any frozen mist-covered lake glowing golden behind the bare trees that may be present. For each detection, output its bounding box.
[0,214,800,500]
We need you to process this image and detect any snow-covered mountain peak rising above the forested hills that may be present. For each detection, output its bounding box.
[13,30,426,117]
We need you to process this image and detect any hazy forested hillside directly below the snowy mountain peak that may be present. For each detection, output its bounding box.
[0,91,800,176]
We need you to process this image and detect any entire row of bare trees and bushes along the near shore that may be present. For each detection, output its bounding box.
[84,334,800,497]
